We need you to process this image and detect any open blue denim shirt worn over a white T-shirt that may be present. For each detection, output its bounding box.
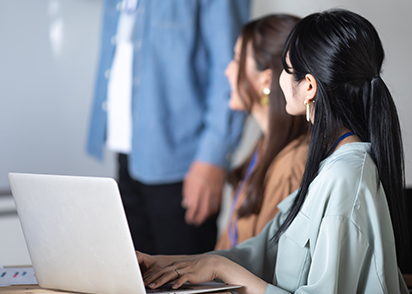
[87,0,250,184]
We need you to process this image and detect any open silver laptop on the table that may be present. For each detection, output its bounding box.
[8,173,240,294]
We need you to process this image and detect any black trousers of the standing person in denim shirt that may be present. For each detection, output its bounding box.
[118,154,217,254]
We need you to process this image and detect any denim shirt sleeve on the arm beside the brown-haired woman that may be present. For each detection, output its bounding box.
[195,0,250,168]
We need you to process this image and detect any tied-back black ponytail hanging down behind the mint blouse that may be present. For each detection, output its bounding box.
[368,76,407,262]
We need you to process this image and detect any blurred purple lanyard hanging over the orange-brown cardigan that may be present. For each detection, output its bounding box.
[228,151,259,247]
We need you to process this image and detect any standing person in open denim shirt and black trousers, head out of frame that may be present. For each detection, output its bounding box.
[87,0,250,254]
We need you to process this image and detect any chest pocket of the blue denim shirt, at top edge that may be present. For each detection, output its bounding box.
[151,0,198,30]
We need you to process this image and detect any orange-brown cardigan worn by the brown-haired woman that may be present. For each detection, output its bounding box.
[215,135,309,250]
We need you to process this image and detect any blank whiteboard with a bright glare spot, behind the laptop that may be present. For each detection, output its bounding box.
[0,0,115,191]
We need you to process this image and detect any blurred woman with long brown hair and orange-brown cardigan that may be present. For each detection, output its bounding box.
[216,14,309,249]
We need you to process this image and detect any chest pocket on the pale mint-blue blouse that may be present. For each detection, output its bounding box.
[275,212,311,292]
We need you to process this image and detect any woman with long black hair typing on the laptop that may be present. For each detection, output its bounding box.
[137,10,409,294]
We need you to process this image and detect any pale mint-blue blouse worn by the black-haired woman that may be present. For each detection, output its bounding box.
[213,143,409,294]
